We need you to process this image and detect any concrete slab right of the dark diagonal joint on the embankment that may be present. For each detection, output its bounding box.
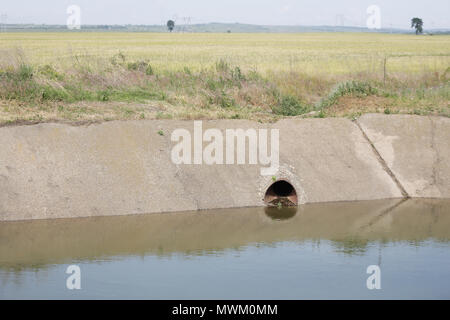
[358,114,450,198]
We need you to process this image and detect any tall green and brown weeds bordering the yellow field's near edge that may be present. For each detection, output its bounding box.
[0,53,450,121]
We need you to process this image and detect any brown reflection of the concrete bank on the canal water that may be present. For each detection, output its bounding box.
[0,200,450,271]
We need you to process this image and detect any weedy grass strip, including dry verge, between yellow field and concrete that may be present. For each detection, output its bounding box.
[0,35,450,125]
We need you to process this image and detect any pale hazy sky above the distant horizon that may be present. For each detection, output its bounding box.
[0,0,450,28]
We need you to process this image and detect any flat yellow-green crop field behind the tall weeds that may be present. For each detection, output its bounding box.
[0,33,450,75]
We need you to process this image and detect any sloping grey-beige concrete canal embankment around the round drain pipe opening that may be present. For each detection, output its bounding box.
[0,115,450,221]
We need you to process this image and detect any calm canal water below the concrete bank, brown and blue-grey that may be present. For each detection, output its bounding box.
[0,200,450,299]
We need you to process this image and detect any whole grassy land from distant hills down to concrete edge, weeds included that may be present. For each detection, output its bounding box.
[0,33,450,125]
